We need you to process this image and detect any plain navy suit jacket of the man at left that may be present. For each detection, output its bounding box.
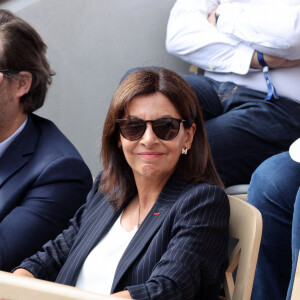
[0,115,92,271]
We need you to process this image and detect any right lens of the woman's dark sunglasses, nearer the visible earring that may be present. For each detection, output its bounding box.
[152,118,180,141]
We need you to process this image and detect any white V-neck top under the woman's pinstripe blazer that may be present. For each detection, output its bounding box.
[76,214,137,295]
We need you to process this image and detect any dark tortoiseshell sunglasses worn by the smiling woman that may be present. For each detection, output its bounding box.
[116,117,186,141]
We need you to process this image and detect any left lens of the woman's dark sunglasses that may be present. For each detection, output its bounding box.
[120,119,146,141]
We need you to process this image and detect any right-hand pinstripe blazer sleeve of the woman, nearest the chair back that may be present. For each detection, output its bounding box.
[126,187,229,299]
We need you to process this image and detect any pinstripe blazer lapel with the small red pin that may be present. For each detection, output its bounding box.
[111,177,187,293]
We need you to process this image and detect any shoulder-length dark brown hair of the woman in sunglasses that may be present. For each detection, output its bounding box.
[101,68,223,209]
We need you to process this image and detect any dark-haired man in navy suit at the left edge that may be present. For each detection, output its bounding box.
[0,10,92,270]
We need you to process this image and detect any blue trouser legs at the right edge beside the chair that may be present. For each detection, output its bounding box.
[248,152,300,300]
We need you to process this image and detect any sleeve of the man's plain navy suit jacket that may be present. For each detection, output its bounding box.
[0,157,92,271]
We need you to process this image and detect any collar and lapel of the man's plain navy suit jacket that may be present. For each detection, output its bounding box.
[0,115,39,187]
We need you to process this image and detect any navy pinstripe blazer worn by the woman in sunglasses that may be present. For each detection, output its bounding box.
[19,176,229,300]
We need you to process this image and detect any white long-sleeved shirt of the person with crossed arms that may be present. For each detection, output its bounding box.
[166,0,300,102]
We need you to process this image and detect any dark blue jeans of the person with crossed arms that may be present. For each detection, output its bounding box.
[181,74,300,186]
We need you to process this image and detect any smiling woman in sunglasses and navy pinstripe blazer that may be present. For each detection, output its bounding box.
[14,69,229,300]
